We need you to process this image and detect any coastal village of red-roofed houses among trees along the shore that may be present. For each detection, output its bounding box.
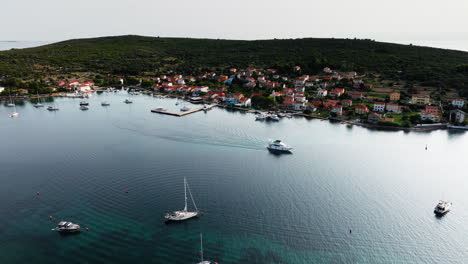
[0,66,466,129]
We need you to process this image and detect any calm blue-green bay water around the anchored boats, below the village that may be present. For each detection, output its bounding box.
[0,93,468,264]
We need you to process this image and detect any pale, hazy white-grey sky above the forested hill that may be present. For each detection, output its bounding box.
[0,0,468,51]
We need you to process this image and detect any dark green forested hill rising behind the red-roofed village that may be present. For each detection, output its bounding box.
[0,36,468,90]
